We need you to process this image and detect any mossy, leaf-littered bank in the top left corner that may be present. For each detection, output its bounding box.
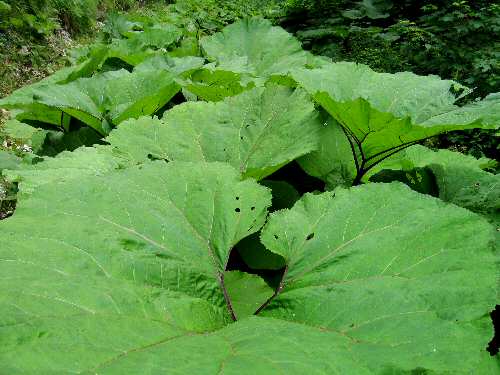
[0,0,160,97]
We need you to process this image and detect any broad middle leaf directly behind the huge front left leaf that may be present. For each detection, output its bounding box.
[108,85,320,179]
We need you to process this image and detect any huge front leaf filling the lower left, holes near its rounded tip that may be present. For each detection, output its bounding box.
[0,162,380,375]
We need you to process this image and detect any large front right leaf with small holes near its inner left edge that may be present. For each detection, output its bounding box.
[261,184,498,373]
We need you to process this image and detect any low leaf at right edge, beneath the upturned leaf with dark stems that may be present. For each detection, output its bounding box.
[368,145,500,225]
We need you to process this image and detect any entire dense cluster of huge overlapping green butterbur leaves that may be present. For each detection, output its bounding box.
[0,13,500,374]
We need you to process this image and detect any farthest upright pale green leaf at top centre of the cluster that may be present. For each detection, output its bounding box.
[200,18,310,77]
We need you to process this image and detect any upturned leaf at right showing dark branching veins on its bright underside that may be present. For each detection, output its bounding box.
[292,62,500,182]
